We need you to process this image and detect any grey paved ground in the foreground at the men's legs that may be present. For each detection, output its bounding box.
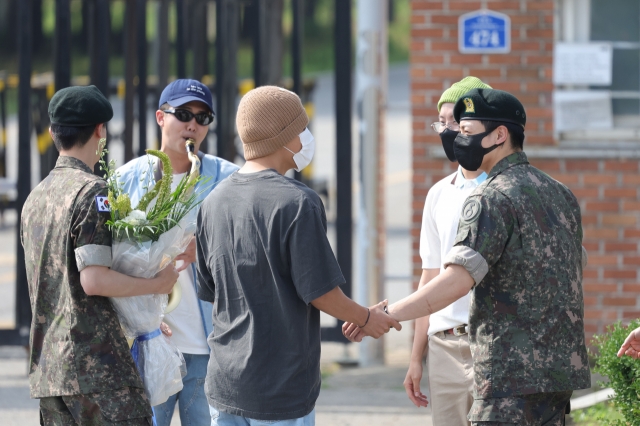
[0,343,431,426]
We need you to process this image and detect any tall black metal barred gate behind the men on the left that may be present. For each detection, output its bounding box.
[0,0,352,346]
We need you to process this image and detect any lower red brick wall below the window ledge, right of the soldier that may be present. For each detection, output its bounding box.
[552,160,640,337]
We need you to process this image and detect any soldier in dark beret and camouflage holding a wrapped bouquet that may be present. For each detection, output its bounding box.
[20,86,178,426]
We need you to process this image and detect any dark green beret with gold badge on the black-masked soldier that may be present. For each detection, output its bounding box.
[453,89,527,127]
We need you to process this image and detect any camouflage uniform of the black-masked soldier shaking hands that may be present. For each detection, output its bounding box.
[444,152,591,425]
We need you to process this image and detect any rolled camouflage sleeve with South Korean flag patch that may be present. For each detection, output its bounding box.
[71,181,111,271]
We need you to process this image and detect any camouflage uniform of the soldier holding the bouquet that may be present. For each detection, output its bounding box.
[20,156,152,424]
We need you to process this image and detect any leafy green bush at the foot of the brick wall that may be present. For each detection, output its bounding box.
[593,320,640,426]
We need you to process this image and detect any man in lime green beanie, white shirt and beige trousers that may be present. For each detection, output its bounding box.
[404,76,491,426]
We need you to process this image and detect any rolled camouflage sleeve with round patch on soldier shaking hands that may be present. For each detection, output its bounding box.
[443,188,517,285]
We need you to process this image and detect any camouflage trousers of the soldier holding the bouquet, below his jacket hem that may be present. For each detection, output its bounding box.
[40,388,153,426]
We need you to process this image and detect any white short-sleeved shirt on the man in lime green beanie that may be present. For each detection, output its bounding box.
[420,167,487,335]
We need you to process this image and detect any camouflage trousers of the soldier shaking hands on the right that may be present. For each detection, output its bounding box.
[469,391,573,426]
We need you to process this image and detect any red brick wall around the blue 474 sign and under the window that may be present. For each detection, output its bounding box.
[410,0,640,344]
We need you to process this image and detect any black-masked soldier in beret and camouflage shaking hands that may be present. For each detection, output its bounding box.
[344,89,591,426]
